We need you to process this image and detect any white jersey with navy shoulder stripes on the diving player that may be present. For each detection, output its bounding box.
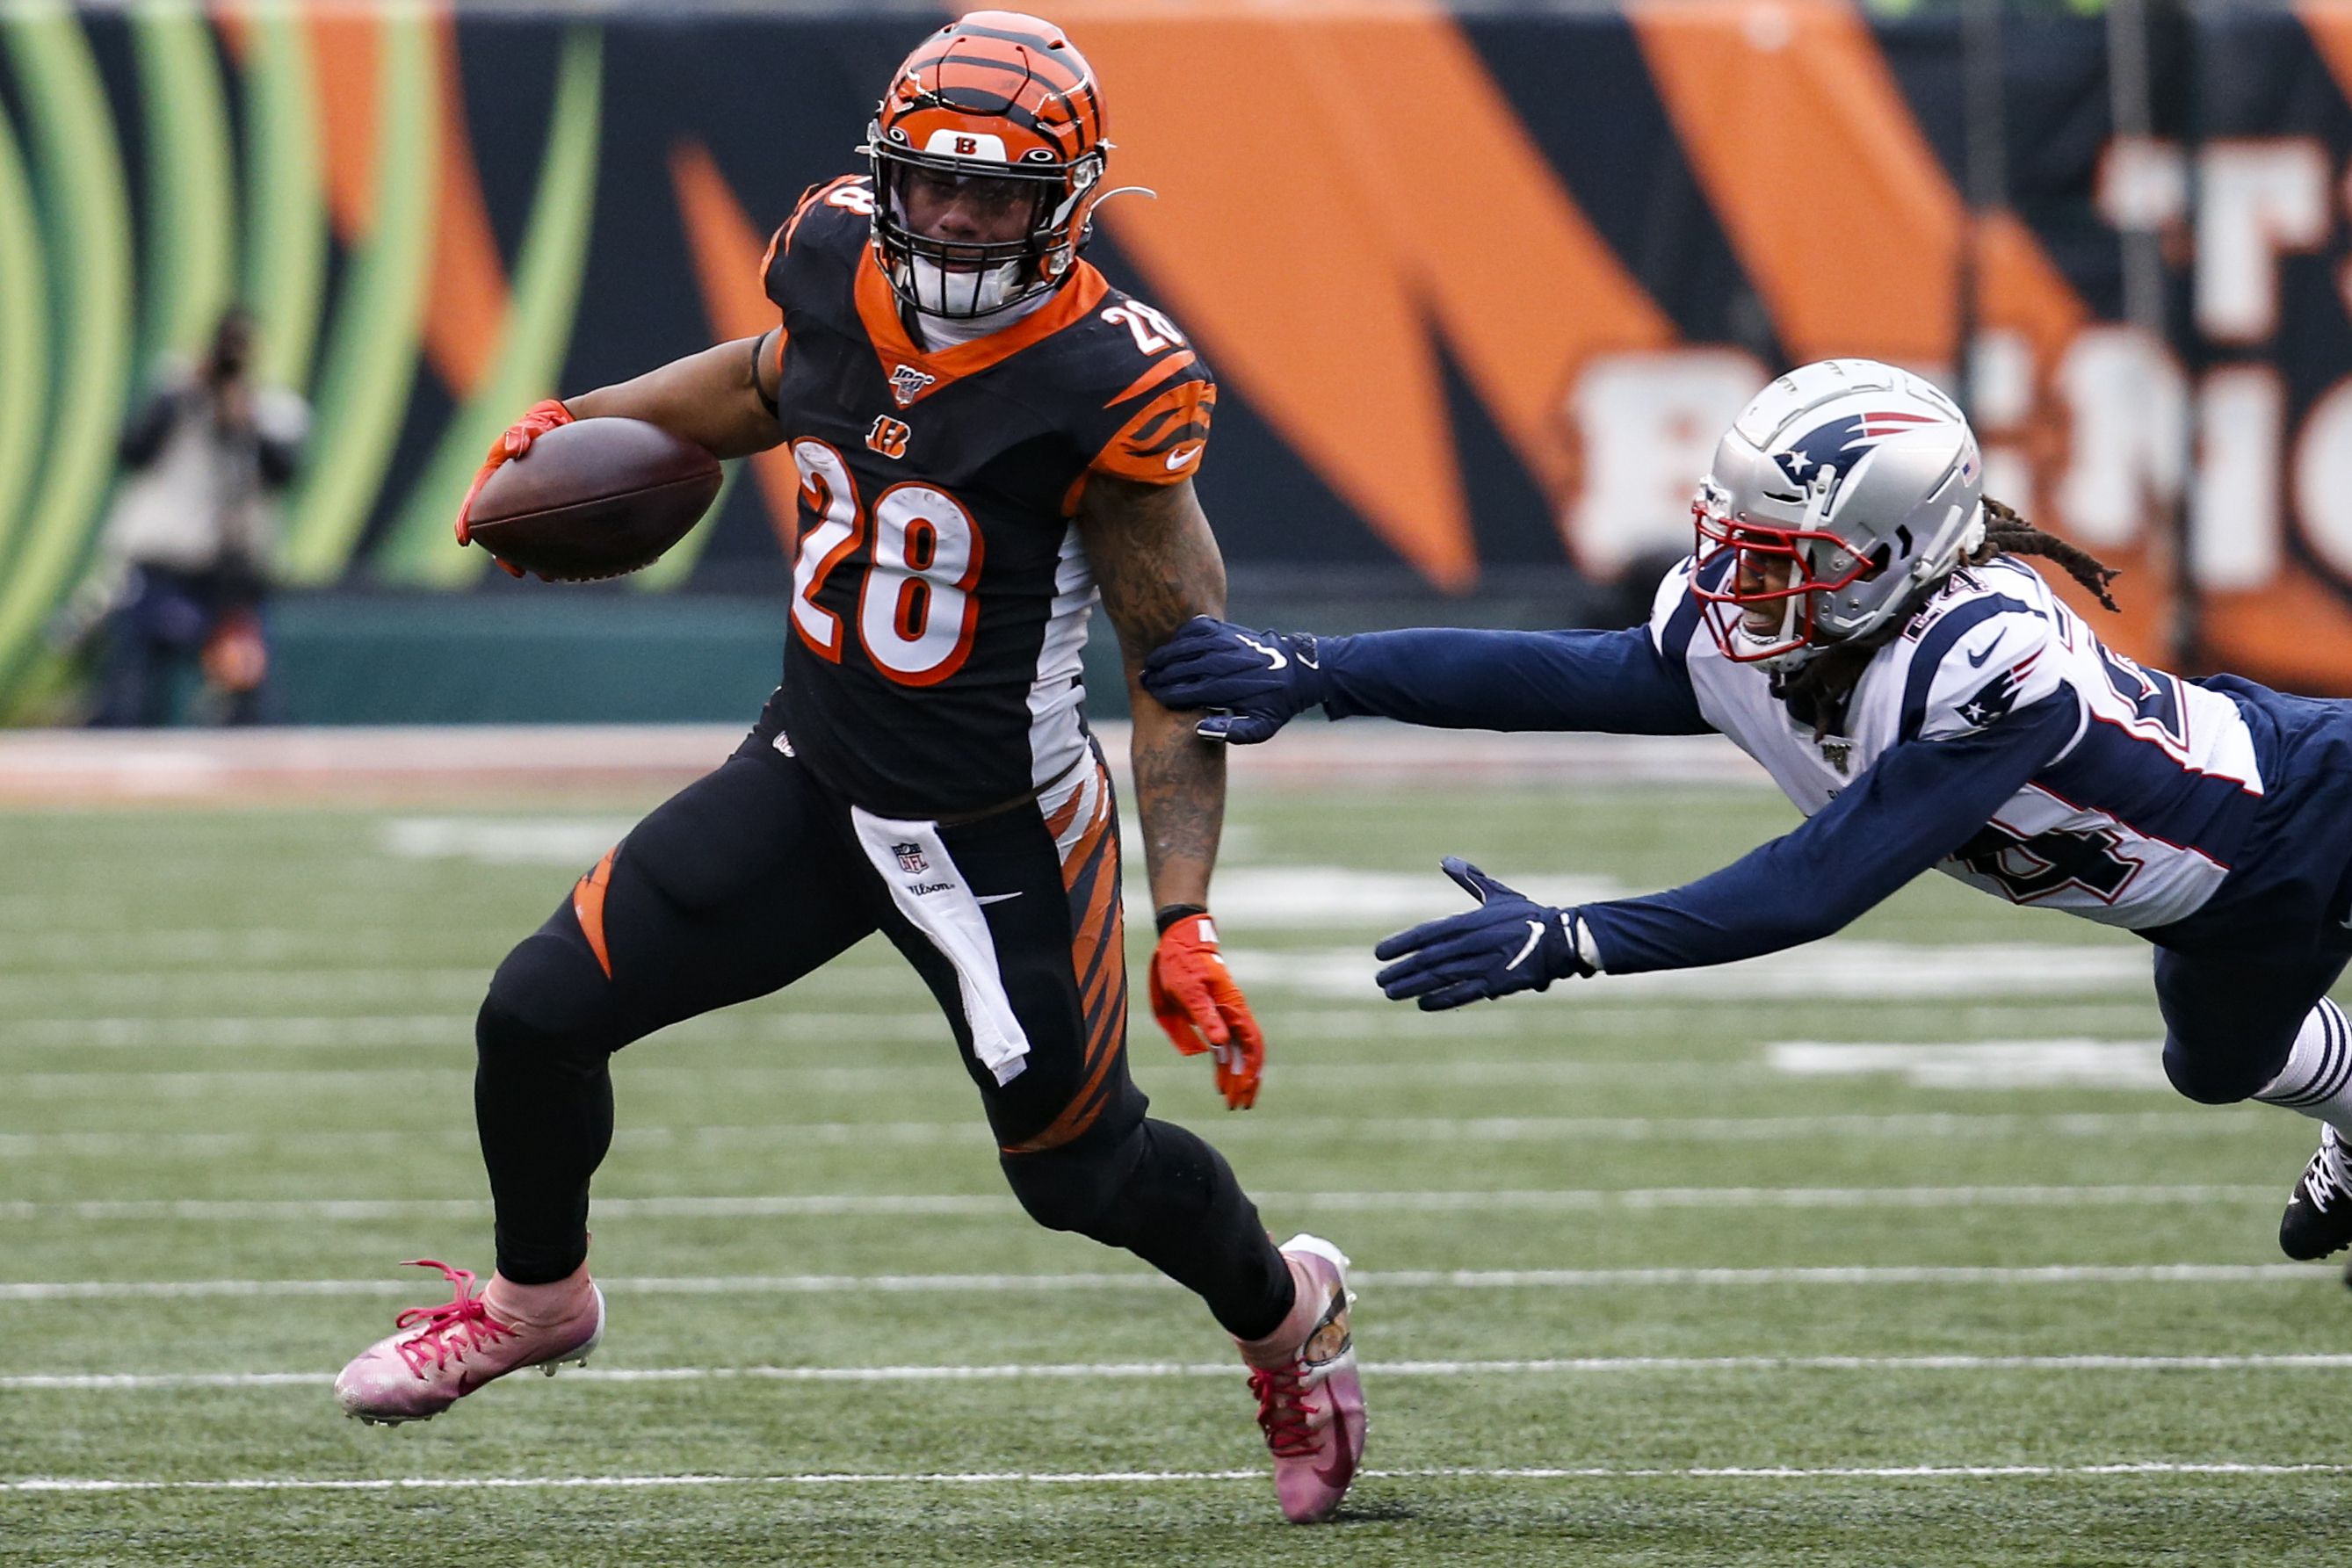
[1649,555,2262,929]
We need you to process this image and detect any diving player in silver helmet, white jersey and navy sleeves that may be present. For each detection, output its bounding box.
[1143,359,2352,1258]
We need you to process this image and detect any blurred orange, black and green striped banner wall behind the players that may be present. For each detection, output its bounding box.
[13,0,2352,691]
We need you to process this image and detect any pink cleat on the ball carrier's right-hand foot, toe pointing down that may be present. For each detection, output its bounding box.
[1234,1234,1364,1523]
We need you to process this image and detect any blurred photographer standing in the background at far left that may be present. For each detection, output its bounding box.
[90,308,310,726]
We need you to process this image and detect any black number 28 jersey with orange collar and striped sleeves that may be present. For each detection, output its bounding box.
[767,177,1216,818]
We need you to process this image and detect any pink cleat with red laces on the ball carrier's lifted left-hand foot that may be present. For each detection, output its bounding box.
[334,1258,604,1427]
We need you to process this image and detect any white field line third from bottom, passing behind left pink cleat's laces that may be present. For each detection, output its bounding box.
[0,1262,2338,1303]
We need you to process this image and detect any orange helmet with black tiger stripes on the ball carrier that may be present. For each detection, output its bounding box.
[865,11,1111,320]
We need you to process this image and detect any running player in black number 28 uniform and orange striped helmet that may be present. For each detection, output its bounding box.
[337,11,1364,1521]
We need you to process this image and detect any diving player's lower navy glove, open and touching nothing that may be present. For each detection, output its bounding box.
[1371,856,1599,1013]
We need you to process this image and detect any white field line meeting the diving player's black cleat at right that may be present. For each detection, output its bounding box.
[0,1182,2279,1223]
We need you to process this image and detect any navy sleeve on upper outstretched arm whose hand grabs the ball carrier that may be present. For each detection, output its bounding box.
[1314,625,1712,736]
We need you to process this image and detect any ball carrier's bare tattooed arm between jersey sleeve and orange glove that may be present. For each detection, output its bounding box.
[1077,473,1226,910]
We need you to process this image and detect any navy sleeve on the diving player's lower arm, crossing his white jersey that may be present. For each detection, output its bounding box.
[1581,691,2081,976]
